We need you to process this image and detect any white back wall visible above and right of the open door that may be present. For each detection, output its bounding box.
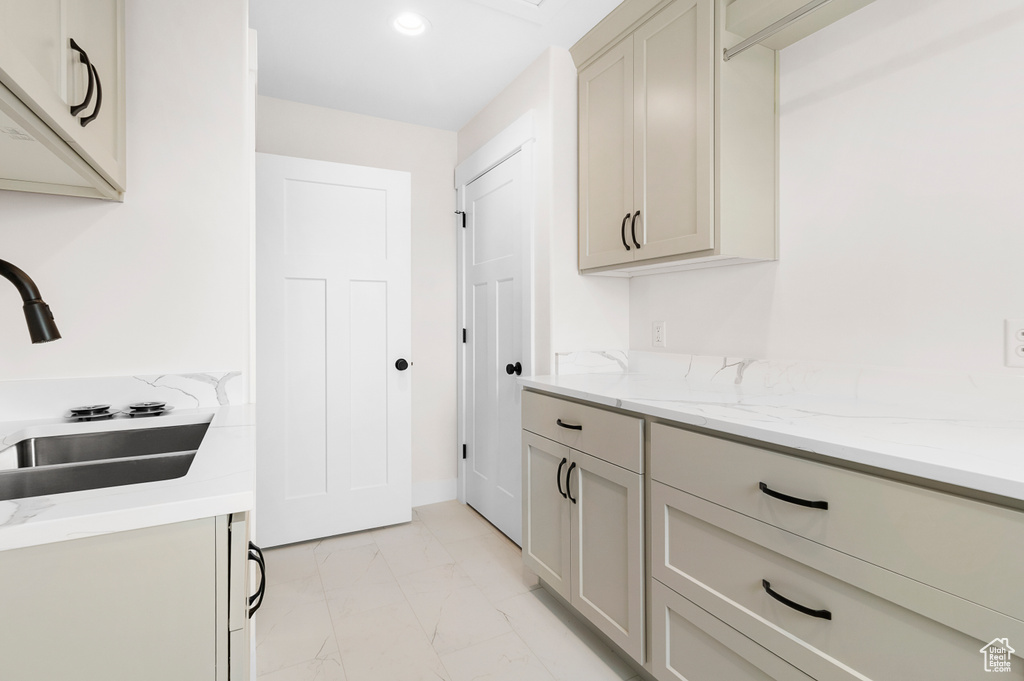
[256,97,457,493]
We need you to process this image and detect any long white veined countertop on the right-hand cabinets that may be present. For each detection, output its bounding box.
[519,374,1024,500]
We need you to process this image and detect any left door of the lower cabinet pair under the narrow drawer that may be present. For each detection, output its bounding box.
[522,430,572,600]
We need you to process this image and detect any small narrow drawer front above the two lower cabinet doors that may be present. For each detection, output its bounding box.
[522,391,643,473]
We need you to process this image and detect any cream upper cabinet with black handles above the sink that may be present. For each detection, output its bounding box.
[0,0,125,199]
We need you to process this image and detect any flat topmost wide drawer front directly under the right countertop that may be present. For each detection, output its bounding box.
[651,424,1024,620]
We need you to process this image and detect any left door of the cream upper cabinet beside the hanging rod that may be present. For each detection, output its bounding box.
[580,37,639,269]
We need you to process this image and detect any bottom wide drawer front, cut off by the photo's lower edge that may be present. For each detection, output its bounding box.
[650,580,811,681]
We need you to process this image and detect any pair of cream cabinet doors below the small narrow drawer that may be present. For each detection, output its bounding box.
[522,430,645,664]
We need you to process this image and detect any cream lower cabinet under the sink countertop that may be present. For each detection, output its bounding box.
[0,513,250,681]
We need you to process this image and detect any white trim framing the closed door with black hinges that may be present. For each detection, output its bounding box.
[453,110,537,504]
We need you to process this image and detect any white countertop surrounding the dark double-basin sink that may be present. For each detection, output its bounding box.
[0,405,256,550]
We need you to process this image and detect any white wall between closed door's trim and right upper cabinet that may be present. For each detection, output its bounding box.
[459,48,629,375]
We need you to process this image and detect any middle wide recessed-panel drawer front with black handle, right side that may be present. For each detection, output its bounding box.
[651,482,1024,681]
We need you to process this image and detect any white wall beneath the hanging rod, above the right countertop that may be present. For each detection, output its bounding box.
[630,0,1024,372]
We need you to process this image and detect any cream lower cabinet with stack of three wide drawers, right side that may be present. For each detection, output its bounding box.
[649,424,1024,681]
